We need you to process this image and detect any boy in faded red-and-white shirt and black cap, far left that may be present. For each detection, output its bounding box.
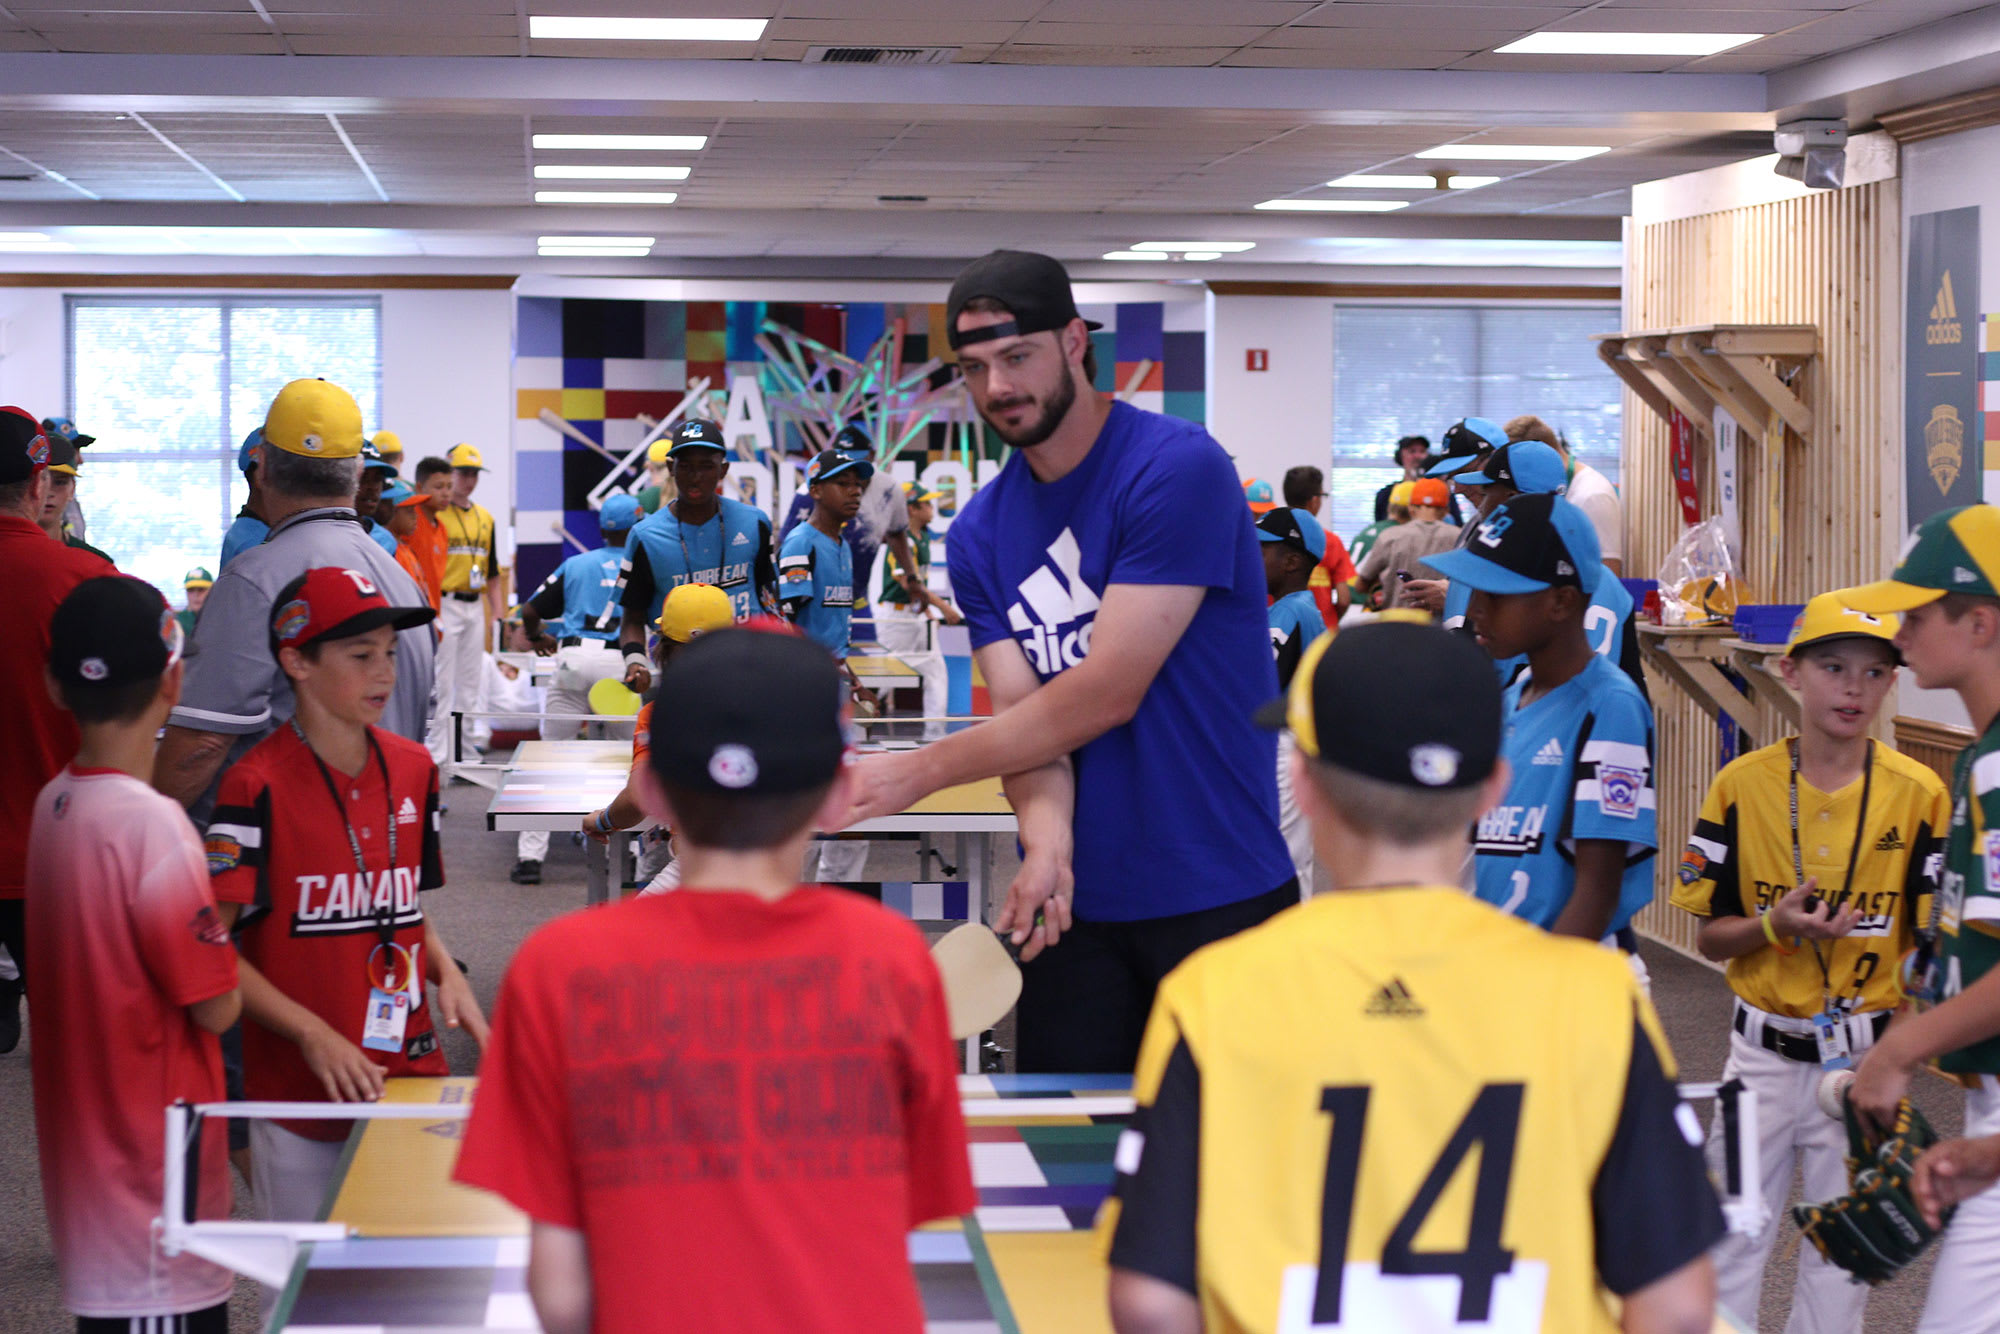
[26,576,242,1334]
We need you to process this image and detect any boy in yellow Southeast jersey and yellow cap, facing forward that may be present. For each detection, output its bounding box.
[1674,592,1950,1334]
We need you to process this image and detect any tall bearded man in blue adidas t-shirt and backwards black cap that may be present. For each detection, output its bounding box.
[850,250,1298,1072]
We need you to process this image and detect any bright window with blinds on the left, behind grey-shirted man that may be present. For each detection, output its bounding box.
[68,296,382,606]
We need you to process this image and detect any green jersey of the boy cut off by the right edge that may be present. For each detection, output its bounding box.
[1938,720,2000,1074]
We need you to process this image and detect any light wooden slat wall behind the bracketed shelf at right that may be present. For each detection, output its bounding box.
[1624,180,1902,950]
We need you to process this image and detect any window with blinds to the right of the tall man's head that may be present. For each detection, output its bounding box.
[1326,306,1622,538]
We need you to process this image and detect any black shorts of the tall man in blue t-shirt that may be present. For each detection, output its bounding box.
[1014,878,1298,1074]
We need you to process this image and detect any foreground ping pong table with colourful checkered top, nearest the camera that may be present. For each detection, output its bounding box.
[268,1076,1132,1334]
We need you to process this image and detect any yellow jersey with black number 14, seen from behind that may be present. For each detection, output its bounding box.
[1100,888,1722,1334]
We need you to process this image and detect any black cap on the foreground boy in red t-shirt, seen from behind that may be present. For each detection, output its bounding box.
[652,630,848,796]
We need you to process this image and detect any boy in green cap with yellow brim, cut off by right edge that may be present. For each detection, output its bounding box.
[1840,504,2000,1334]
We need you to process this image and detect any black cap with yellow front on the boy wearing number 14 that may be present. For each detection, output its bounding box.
[1256,620,1500,790]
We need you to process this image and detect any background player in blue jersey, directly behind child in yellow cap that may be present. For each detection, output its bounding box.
[618,418,778,690]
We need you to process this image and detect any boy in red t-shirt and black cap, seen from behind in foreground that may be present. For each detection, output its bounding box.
[458,630,976,1334]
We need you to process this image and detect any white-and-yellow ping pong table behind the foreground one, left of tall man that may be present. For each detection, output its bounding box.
[486,740,1020,922]
